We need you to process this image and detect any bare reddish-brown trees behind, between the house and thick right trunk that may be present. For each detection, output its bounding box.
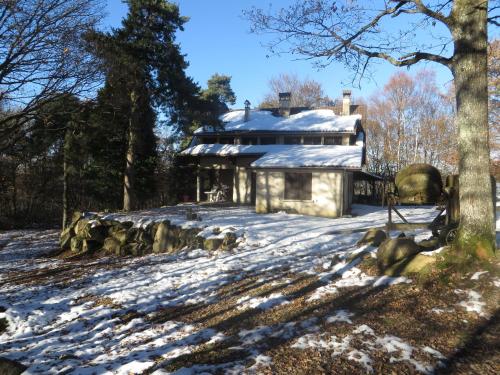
[365,70,456,174]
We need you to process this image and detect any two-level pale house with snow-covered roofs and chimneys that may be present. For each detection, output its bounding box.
[182,90,374,217]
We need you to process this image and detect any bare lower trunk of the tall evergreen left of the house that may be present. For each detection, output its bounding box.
[123,90,139,211]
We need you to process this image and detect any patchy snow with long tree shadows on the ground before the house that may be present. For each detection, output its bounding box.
[0,205,468,374]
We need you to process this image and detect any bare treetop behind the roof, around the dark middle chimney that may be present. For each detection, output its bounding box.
[259,73,332,108]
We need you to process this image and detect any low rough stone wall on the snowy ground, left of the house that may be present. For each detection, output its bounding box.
[60,213,237,256]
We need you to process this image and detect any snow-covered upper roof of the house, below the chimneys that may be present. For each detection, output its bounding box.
[195,109,361,134]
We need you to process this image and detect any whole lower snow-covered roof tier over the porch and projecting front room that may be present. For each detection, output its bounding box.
[182,144,363,168]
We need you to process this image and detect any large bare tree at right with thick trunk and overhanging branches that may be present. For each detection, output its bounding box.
[245,0,500,258]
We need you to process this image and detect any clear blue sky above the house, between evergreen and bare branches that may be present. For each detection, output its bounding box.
[105,0,458,108]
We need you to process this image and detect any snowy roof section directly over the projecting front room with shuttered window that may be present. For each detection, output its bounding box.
[251,145,363,168]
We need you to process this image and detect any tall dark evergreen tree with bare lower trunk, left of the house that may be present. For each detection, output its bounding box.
[89,0,199,211]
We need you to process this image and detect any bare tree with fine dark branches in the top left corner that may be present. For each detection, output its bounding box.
[0,0,103,151]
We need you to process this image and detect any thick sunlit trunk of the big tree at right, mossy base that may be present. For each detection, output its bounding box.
[452,0,495,259]
